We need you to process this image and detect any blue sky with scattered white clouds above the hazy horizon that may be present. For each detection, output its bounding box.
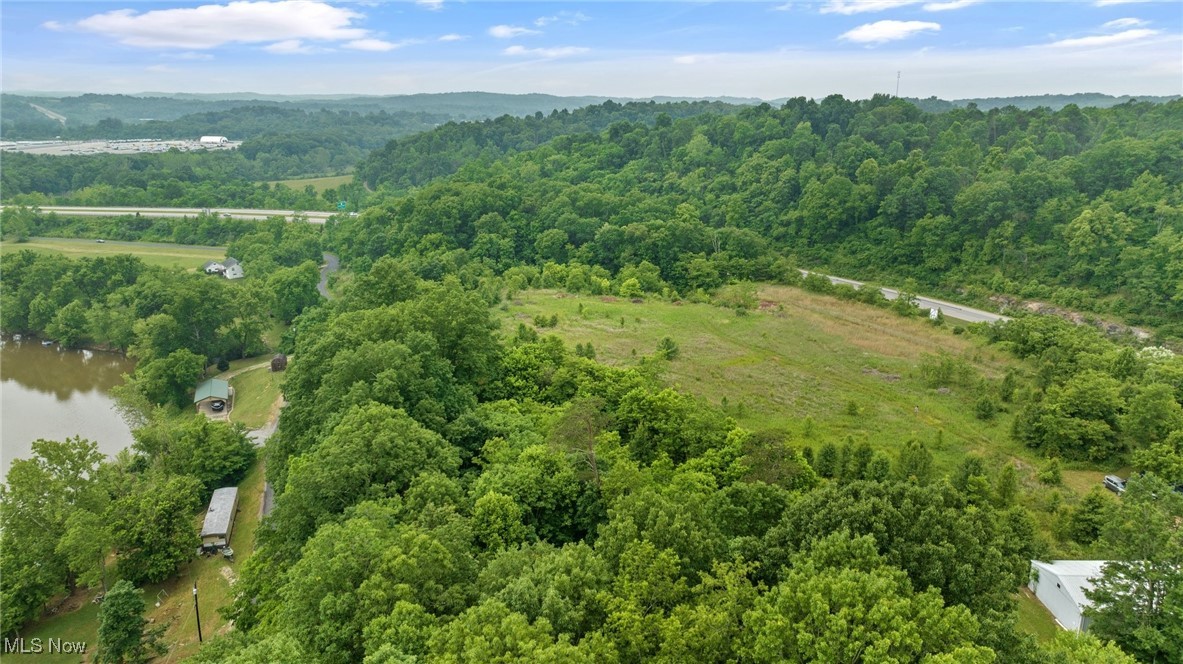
[0,0,1183,99]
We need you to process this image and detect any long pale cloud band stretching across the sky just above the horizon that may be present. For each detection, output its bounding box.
[11,32,1183,99]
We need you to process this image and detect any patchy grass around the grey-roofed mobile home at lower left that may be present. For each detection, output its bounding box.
[4,458,264,664]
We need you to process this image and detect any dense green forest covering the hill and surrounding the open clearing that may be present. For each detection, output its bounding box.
[0,97,1183,664]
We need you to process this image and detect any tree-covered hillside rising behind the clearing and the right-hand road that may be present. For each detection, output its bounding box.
[340,96,1183,336]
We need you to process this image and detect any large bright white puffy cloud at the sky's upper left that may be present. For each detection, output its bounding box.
[64,0,369,50]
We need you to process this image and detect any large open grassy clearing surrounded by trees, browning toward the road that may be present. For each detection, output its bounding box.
[500,286,1040,475]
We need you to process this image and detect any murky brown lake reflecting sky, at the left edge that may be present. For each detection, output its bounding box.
[0,339,135,479]
